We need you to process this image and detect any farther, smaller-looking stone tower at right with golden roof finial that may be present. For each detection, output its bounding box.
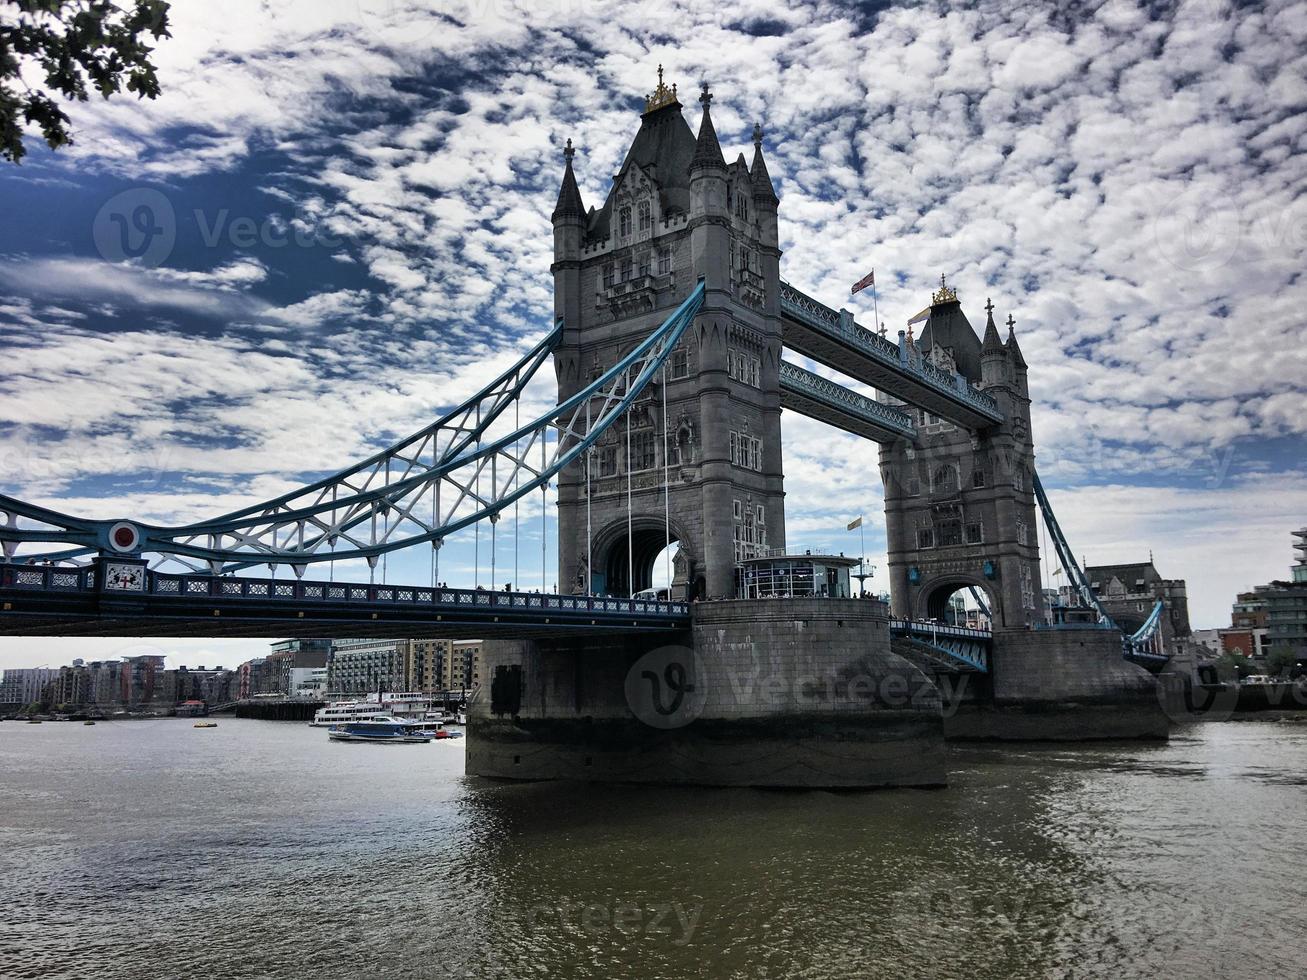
[881,277,1044,630]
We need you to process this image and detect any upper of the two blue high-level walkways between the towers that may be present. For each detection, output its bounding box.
[780,282,1004,428]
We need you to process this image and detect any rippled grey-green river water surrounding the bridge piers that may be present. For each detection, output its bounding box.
[0,717,1307,980]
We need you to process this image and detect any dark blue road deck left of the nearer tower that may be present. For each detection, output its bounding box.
[0,564,690,639]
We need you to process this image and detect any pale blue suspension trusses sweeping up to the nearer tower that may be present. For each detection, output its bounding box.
[0,282,704,572]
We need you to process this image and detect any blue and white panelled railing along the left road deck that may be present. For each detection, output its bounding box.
[0,564,690,618]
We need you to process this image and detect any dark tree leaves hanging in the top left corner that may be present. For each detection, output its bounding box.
[0,0,171,163]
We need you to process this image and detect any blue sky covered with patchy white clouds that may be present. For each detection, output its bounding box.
[0,0,1307,666]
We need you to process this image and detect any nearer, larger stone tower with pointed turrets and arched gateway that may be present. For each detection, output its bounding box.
[552,68,786,597]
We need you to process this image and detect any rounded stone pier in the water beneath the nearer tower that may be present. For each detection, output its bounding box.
[467,598,946,788]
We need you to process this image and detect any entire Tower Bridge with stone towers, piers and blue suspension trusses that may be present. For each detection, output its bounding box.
[0,71,1166,787]
